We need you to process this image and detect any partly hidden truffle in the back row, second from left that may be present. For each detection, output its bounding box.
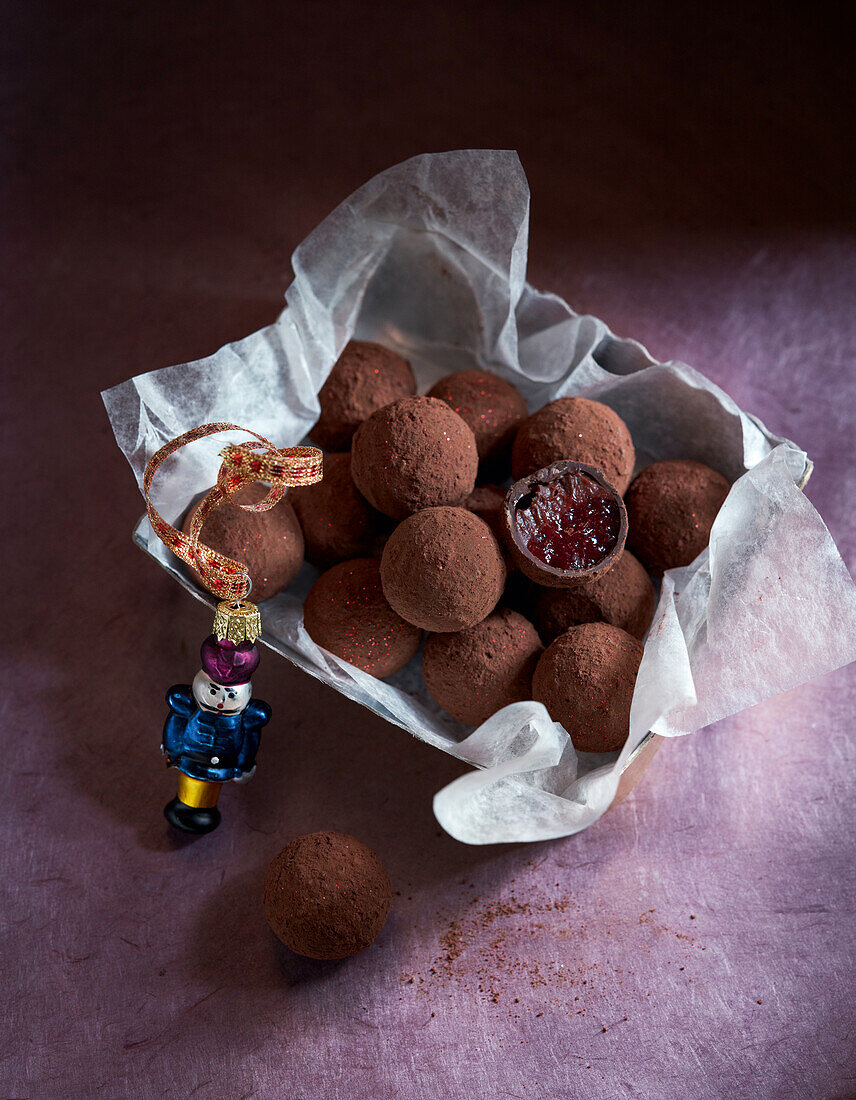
[428,371,529,461]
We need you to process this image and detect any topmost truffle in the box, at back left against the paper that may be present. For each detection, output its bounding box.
[309,340,416,451]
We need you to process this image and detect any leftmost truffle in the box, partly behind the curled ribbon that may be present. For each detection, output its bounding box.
[182,482,304,604]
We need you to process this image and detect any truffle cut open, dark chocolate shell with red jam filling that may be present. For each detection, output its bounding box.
[503,461,627,589]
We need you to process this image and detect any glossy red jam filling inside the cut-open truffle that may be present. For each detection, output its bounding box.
[514,472,621,572]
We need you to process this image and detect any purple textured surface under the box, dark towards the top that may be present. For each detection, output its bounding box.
[0,2,856,1100]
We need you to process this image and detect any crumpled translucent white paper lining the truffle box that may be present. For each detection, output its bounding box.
[103,150,856,844]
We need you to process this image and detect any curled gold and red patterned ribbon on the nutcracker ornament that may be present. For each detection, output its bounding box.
[143,424,323,600]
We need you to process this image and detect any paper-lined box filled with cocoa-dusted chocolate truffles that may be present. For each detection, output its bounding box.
[103,151,856,844]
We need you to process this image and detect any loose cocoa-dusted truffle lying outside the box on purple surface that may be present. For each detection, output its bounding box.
[264,833,393,959]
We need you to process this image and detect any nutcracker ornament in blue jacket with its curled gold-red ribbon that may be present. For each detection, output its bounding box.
[143,424,322,834]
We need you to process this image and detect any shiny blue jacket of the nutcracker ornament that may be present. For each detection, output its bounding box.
[164,684,271,783]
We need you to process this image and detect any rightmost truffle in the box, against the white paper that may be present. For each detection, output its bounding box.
[626,460,731,573]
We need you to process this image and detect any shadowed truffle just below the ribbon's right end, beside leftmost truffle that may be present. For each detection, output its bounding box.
[288,451,388,569]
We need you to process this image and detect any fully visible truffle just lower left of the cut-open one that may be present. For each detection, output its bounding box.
[381,503,505,631]
